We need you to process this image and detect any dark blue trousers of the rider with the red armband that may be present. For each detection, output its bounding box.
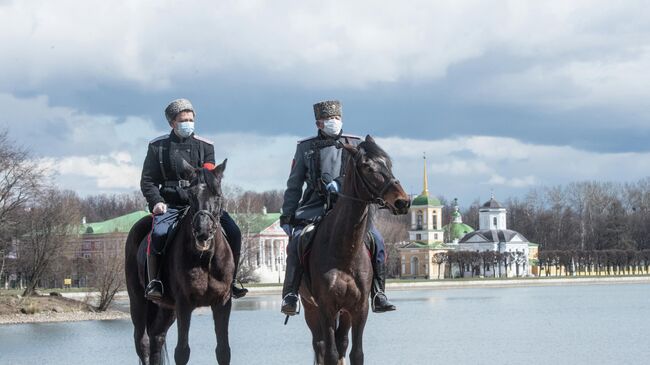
[147,208,241,258]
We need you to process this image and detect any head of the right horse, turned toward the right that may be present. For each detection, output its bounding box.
[343,136,411,215]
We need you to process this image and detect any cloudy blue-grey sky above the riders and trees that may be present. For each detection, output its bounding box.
[0,0,650,205]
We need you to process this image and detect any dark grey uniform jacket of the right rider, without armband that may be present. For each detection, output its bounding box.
[280,131,361,225]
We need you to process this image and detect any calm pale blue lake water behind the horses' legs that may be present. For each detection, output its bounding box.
[0,284,650,365]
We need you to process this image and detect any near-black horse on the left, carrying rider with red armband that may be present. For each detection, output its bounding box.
[125,160,235,365]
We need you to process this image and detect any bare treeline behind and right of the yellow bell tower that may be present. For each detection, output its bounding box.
[444,178,650,251]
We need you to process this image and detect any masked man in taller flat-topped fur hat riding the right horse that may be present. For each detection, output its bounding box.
[280,100,395,315]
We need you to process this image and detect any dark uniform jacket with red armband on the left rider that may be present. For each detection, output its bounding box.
[140,130,215,210]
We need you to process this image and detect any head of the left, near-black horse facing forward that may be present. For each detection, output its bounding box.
[183,159,228,252]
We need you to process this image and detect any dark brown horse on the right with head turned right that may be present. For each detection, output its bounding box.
[300,136,410,365]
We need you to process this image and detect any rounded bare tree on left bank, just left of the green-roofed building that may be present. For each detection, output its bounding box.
[19,189,81,295]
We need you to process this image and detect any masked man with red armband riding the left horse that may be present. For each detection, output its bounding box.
[140,99,248,300]
